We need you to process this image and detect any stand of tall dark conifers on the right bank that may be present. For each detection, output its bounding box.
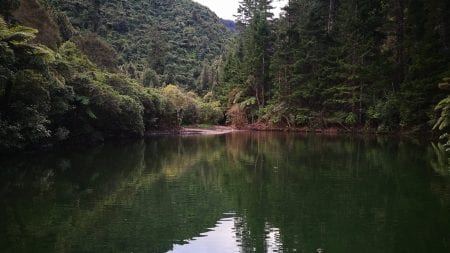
[215,0,450,131]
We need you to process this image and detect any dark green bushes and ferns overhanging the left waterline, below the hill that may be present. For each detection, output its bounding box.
[0,19,175,151]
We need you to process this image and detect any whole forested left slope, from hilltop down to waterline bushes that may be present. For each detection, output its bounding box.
[0,0,228,152]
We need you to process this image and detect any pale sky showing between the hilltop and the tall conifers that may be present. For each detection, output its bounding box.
[194,0,288,20]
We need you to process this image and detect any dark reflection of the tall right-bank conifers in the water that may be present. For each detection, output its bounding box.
[221,134,450,252]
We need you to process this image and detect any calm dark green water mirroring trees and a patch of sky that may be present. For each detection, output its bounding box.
[0,133,450,253]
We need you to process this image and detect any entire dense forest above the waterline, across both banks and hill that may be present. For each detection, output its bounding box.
[0,0,450,151]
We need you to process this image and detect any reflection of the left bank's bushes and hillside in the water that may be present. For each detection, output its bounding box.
[0,138,230,252]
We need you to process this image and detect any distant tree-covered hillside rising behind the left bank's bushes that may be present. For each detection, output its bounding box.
[48,0,231,89]
